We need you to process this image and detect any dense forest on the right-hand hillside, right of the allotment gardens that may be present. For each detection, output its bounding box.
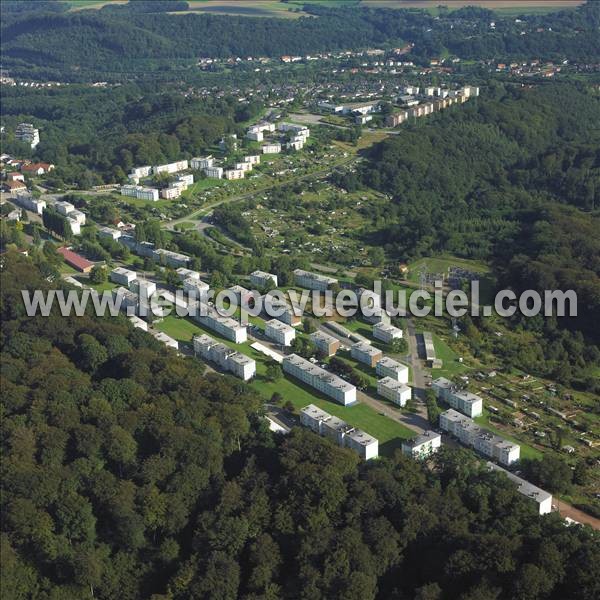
[358,83,600,390]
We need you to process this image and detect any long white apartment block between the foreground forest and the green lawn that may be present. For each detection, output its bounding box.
[300,404,379,460]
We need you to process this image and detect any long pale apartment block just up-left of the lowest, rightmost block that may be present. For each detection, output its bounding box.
[440,408,521,466]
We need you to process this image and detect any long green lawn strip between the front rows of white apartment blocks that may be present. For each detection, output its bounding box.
[155,315,415,456]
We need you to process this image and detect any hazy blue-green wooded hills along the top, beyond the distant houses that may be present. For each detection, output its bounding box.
[2,2,600,81]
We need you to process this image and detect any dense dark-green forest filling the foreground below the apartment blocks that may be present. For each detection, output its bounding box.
[0,252,600,600]
